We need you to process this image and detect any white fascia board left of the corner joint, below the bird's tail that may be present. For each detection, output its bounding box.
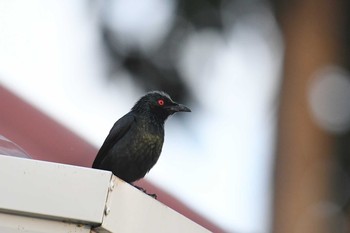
[0,155,112,225]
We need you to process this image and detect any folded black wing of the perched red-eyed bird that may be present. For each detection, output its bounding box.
[92,113,135,168]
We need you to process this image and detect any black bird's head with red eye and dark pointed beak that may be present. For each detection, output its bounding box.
[132,91,191,122]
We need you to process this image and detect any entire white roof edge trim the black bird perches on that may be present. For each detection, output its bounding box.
[0,155,209,233]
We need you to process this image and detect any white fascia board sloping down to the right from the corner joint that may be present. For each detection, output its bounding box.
[95,176,210,233]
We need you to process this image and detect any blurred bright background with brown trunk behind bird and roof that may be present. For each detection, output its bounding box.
[0,0,350,233]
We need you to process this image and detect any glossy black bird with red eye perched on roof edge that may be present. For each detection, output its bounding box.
[92,91,191,183]
